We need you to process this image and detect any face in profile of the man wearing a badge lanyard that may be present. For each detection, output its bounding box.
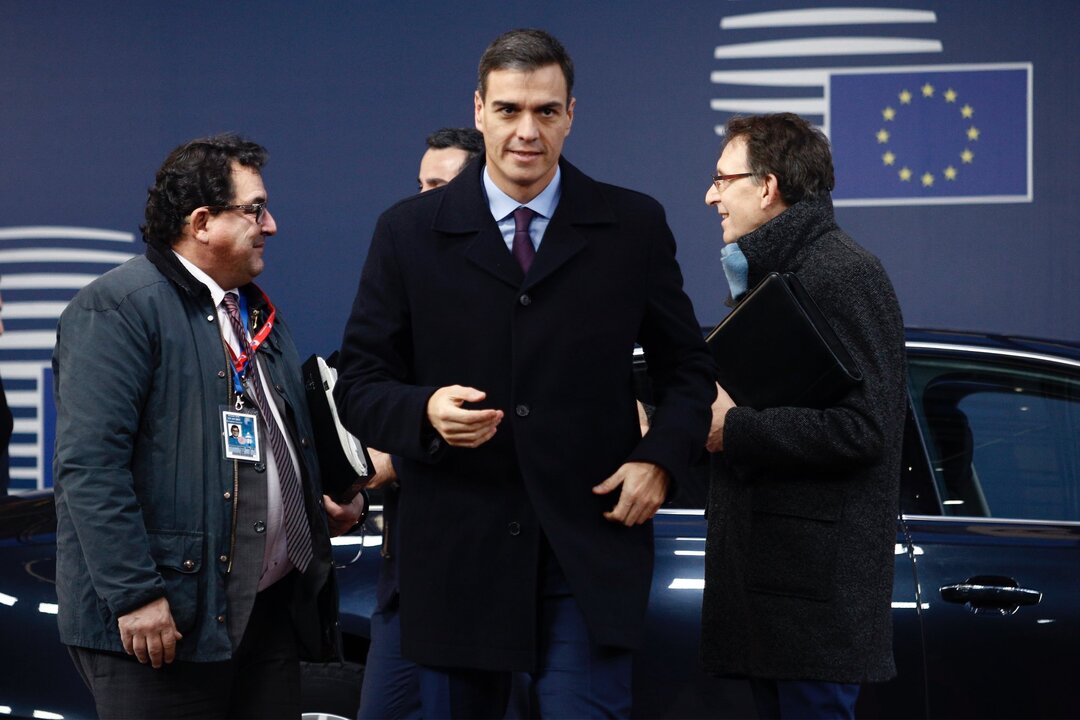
[204,163,278,290]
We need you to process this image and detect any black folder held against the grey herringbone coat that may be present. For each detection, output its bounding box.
[706,273,862,410]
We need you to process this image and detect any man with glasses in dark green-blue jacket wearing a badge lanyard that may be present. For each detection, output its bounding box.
[53,135,363,718]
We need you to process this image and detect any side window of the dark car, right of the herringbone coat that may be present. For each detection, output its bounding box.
[909,356,1080,521]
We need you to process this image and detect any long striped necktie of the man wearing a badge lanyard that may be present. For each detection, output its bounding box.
[221,293,313,573]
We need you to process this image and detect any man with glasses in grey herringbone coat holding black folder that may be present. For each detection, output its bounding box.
[702,113,906,718]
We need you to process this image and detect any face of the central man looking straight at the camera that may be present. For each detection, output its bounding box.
[473,64,575,204]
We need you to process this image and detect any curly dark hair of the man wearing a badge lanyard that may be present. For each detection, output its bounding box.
[139,133,267,247]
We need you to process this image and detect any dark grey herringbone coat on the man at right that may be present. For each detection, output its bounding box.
[702,199,906,682]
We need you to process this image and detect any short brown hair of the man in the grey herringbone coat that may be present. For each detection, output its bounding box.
[725,112,836,205]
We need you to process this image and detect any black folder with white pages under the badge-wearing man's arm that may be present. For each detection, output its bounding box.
[302,355,375,502]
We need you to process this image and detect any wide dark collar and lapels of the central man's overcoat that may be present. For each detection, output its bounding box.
[432,155,616,287]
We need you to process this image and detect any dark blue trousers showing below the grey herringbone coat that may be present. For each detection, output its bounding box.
[750,679,860,720]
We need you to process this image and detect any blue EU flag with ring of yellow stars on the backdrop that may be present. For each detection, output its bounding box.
[827,65,1031,205]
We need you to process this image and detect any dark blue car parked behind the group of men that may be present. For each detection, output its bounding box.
[0,330,1080,718]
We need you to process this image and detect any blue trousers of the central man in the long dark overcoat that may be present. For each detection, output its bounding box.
[420,551,633,718]
